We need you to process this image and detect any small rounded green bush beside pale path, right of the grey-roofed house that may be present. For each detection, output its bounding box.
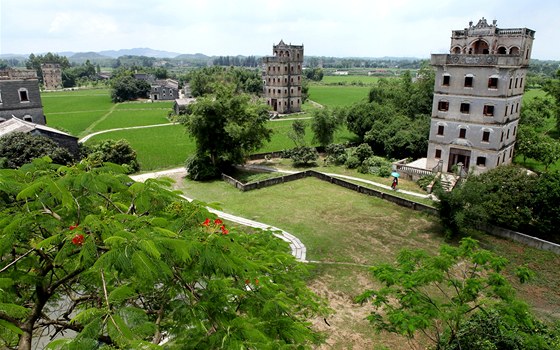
[85,139,140,174]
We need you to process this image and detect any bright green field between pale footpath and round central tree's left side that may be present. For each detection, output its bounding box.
[87,125,195,171]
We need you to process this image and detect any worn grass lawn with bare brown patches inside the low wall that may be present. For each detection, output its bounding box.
[171,174,560,349]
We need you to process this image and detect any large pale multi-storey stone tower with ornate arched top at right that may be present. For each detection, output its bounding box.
[426,18,535,173]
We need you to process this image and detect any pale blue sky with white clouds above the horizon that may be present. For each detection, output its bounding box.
[0,0,560,60]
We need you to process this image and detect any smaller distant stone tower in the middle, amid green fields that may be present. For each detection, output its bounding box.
[262,40,303,114]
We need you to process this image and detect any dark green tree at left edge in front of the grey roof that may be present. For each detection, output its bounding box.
[0,132,74,169]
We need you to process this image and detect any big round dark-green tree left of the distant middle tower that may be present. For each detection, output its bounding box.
[183,85,272,178]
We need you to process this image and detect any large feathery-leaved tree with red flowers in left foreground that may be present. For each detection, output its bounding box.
[0,159,325,350]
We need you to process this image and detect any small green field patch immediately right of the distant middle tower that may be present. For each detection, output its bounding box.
[309,85,370,107]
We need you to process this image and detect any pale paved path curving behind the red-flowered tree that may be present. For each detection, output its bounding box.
[131,168,307,262]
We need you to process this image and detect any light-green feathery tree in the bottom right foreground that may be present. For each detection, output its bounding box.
[357,238,532,349]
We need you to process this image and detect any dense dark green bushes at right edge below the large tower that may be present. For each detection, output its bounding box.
[438,166,560,241]
